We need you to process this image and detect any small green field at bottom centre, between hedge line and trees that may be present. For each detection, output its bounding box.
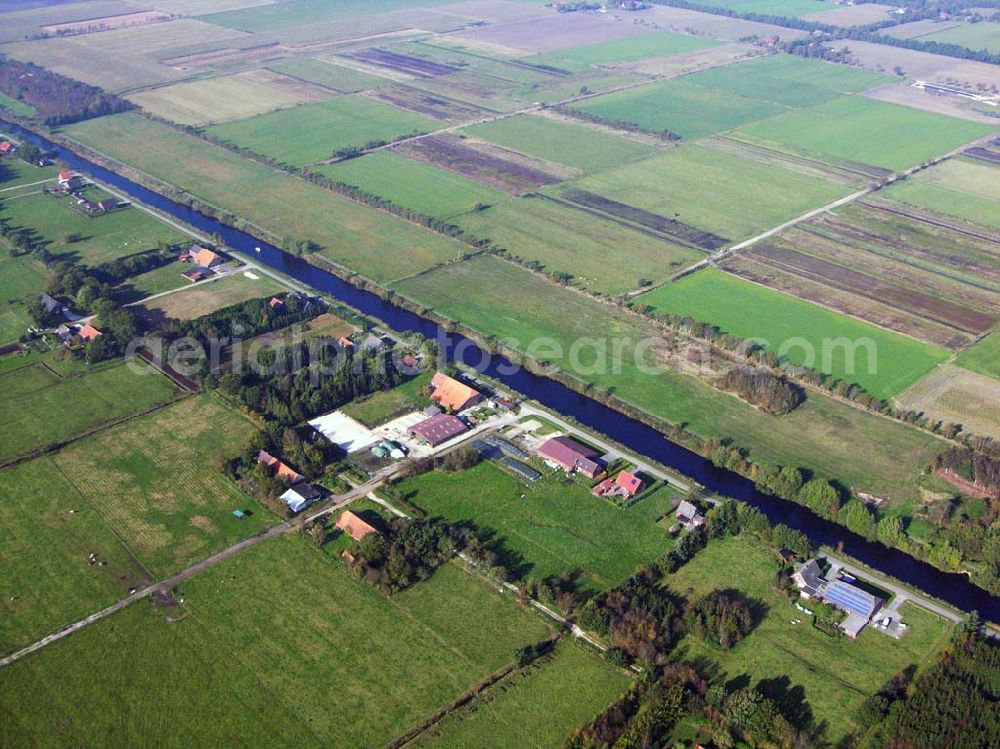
[413,640,631,749]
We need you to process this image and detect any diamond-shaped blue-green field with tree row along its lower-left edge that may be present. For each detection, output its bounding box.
[571,79,782,140]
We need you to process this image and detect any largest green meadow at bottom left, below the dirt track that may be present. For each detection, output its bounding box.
[0,535,550,747]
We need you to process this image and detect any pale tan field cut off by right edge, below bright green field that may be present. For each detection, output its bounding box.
[899,364,1000,440]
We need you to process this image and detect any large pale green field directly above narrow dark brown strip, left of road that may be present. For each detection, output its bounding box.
[570,145,850,242]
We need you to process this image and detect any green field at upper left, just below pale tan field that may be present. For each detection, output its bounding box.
[206,96,437,166]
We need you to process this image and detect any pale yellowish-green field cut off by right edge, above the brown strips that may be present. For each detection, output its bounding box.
[885,159,1000,229]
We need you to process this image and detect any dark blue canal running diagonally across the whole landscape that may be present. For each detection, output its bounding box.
[0,120,1000,622]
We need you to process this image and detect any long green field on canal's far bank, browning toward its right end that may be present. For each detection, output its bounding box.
[393,257,940,501]
